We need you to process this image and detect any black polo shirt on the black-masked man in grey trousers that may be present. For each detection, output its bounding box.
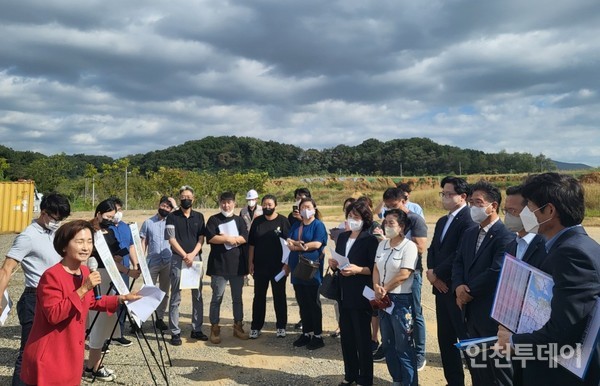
[165,209,206,254]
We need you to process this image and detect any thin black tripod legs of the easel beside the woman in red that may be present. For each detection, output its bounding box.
[85,279,173,386]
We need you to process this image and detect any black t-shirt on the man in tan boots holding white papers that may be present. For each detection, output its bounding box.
[206,213,248,276]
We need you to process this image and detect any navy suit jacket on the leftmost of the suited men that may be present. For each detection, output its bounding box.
[427,205,477,294]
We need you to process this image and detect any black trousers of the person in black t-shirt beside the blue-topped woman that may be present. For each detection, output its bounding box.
[250,275,287,330]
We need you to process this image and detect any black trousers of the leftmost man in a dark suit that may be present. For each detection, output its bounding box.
[435,291,467,386]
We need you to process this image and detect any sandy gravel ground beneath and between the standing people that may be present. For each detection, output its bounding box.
[0,210,600,385]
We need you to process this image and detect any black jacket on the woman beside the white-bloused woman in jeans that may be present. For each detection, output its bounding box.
[335,230,379,309]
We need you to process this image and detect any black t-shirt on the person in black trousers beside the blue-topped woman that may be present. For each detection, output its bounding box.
[248,214,290,277]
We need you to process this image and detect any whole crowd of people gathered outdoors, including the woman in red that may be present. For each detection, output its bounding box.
[0,173,600,386]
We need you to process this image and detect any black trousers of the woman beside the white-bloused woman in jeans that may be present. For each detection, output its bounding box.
[340,307,373,385]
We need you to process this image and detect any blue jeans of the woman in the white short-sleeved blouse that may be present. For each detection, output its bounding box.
[379,294,418,386]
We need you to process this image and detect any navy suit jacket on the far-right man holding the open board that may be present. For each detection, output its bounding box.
[512,227,600,386]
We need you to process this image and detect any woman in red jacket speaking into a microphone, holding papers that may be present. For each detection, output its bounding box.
[21,220,140,385]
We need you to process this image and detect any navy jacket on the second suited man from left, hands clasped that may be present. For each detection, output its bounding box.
[452,220,516,335]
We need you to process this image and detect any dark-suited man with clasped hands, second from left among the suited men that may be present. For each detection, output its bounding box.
[452,181,515,386]
